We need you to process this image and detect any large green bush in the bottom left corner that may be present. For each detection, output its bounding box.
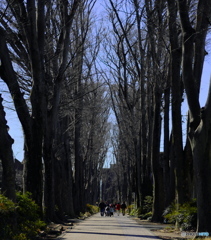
[0,193,46,240]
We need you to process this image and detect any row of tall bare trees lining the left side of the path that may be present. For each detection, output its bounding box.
[0,0,109,221]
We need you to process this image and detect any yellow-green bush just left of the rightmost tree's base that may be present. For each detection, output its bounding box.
[163,199,197,231]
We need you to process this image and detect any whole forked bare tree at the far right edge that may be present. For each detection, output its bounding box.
[177,0,211,232]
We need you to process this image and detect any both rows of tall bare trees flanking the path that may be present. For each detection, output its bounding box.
[0,0,211,232]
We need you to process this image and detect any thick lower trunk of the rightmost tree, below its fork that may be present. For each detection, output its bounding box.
[191,112,211,232]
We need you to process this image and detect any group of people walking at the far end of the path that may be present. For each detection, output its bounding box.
[99,201,127,217]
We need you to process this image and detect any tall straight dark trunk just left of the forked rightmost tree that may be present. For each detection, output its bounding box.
[168,0,188,204]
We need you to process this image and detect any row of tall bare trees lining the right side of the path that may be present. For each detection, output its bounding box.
[101,0,211,232]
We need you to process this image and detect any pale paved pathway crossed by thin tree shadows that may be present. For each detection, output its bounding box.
[59,214,158,240]
